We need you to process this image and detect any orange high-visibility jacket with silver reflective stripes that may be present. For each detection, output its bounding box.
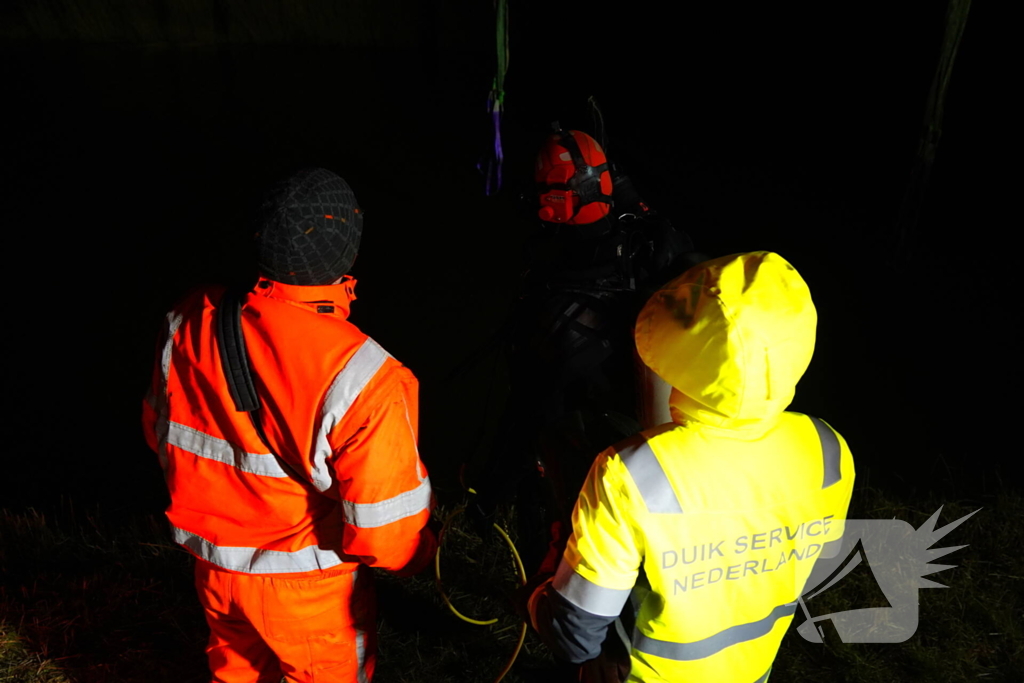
[143,278,435,573]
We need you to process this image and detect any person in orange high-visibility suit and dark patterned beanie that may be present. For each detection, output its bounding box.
[143,169,436,683]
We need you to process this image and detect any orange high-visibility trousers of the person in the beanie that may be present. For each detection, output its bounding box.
[196,560,377,683]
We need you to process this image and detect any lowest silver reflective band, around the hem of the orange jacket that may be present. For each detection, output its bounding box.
[171,525,345,573]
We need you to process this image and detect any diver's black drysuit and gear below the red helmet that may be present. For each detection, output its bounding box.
[468,131,706,575]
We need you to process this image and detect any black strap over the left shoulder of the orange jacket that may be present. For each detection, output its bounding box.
[216,288,309,487]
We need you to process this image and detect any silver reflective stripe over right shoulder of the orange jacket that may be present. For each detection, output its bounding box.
[312,338,390,492]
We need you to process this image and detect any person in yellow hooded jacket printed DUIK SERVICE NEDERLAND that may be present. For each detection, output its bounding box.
[527,252,854,683]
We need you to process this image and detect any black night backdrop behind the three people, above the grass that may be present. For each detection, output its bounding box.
[0,0,1020,520]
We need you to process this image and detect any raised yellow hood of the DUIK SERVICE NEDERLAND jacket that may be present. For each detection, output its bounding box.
[635,252,817,436]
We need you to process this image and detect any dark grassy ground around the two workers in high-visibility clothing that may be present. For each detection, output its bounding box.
[0,488,1024,683]
